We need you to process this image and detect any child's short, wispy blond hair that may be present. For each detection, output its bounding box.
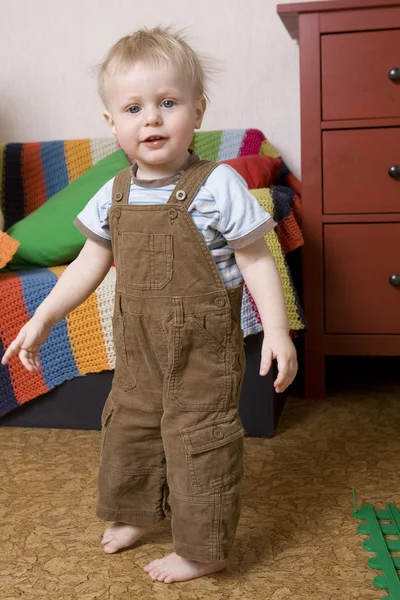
[98,27,211,106]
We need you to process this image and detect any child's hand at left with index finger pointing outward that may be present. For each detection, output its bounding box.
[1,317,52,373]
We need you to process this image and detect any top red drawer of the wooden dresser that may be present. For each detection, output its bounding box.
[321,29,400,121]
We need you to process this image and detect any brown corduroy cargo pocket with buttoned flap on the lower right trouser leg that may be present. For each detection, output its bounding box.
[181,414,245,493]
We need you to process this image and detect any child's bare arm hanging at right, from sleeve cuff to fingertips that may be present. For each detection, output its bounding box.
[235,238,297,392]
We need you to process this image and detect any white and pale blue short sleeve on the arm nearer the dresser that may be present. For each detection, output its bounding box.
[205,164,276,250]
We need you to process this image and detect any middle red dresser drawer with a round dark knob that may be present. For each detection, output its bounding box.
[322,127,400,214]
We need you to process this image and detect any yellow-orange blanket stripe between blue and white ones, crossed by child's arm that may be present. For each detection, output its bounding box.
[50,266,110,374]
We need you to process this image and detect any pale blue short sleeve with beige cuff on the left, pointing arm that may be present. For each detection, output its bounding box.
[74,178,115,247]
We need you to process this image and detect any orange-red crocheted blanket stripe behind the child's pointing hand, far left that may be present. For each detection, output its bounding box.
[0,273,49,404]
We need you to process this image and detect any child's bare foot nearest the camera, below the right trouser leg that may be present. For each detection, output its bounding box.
[144,552,228,583]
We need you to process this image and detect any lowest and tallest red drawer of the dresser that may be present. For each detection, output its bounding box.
[324,223,400,334]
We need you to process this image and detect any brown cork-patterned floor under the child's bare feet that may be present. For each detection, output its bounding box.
[0,356,400,600]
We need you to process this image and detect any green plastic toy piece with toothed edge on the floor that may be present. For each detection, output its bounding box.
[353,488,400,600]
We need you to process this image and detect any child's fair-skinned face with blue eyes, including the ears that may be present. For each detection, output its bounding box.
[105,63,206,177]
